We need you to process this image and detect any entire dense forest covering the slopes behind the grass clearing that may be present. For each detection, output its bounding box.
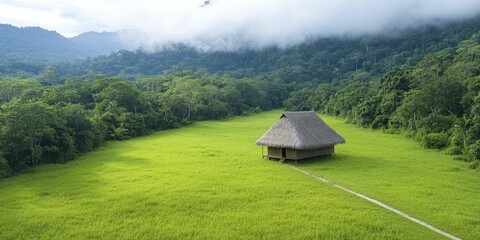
[0,17,480,177]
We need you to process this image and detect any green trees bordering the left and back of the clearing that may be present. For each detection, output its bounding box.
[0,71,287,177]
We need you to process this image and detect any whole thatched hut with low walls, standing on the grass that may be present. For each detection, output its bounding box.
[256,111,345,160]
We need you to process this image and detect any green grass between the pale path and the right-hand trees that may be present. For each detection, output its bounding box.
[298,116,480,239]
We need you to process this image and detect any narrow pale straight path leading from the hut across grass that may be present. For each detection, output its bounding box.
[285,164,461,240]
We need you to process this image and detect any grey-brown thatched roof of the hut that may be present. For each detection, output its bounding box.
[256,111,345,150]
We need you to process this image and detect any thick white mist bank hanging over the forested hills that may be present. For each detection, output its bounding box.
[113,0,480,51]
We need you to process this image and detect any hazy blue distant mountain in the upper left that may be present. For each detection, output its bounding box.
[0,24,131,61]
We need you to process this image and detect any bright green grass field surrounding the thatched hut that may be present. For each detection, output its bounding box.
[0,111,480,239]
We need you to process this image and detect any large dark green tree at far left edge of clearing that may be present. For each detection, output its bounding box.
[0,101,73,172]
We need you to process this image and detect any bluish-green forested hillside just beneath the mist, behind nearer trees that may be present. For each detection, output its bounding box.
[0,17,480,86]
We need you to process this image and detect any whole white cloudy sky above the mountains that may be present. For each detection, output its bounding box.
[0,0,480,50]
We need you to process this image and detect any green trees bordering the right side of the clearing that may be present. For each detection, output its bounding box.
[285,34,480,168]
